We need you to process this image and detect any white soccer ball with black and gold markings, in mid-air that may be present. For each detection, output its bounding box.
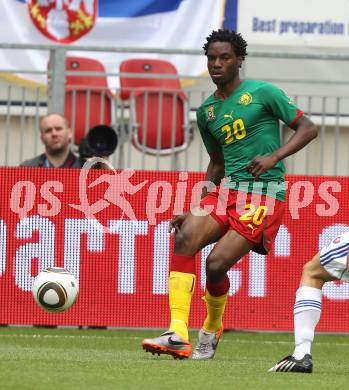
[32,267,79,312]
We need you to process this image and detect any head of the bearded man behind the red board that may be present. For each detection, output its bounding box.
[40,114,72,155]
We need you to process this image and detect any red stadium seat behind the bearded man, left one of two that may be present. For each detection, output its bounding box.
[64,57,113,144]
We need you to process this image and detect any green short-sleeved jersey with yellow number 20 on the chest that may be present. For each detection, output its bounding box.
[197,80,303,201]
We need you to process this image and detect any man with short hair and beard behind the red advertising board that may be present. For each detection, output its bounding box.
[20,112,85,168]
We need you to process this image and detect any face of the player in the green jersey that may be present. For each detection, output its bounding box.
[207,42,242,85]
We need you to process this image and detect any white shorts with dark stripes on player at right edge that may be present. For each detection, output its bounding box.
[320,233,349,282]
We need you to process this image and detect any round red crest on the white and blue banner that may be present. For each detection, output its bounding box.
[28,0,97,43]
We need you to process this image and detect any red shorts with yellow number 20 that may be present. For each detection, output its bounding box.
[200,187,285,255]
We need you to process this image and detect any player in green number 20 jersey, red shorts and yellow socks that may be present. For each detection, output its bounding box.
[142,30,317,359]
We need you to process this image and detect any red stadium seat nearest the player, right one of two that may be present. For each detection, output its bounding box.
[120,59,189,155]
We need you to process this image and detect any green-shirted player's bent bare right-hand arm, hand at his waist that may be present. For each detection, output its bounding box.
[246,115,318,179]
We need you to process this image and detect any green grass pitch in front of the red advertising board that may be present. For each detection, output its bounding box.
[0,327,349,390]
